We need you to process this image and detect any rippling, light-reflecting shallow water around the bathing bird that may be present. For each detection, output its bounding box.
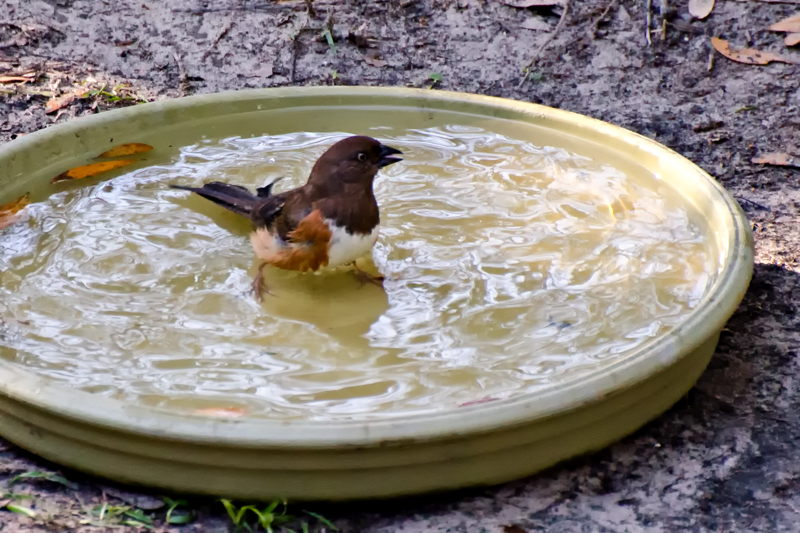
[0,126,717,419]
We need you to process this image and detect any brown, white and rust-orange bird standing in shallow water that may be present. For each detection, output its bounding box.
[171,135,403,300]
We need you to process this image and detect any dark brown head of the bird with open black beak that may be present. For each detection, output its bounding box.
[309,135,403,186]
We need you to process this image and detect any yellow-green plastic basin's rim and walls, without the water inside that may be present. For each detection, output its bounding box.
[0,87,753,500]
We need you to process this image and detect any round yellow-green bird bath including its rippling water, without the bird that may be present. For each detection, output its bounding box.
[0,87,753,499]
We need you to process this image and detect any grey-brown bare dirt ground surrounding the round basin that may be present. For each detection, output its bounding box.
[0,0,800,533]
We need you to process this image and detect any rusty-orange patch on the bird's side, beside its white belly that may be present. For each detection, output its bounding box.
[270,209,332,272]
